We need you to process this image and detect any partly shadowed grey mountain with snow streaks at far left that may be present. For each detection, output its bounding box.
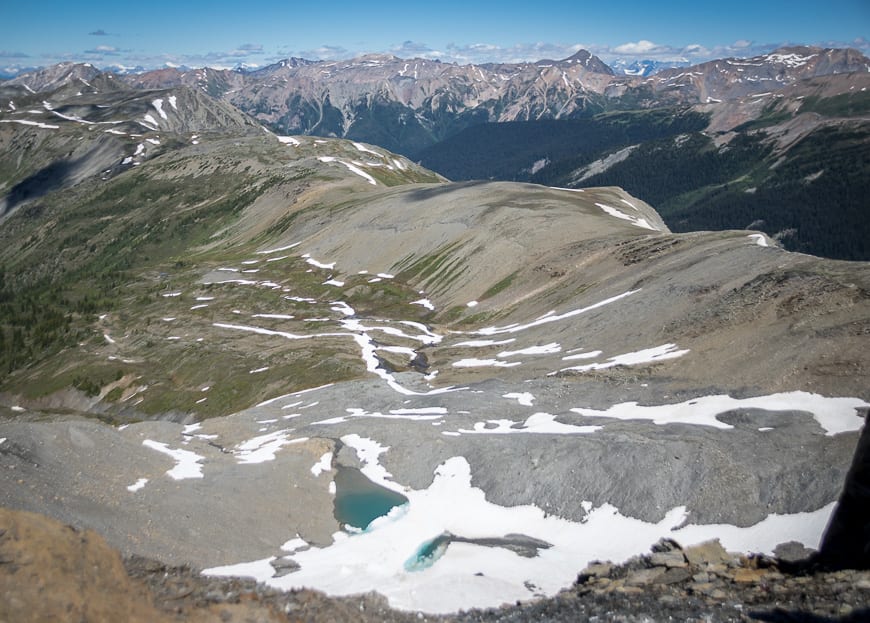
[0,71,263,218]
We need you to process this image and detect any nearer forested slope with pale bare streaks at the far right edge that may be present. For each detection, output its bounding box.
[532,74,870,259]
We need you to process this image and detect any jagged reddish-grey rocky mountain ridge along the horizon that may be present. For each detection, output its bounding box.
[6,46,870,155]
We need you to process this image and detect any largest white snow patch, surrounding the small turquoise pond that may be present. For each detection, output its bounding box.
[203,448,834,613]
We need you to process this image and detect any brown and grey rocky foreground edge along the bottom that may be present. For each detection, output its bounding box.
[0,412,870,623]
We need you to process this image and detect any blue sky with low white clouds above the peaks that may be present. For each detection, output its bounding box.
[0,0,870,71]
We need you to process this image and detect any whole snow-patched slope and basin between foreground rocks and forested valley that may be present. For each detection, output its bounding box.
[0,67,870,613]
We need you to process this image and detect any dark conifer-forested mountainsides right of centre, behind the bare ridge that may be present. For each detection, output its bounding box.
[418,63,870,259]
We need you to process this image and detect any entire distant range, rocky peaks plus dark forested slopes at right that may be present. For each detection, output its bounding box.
[0,47,870,259]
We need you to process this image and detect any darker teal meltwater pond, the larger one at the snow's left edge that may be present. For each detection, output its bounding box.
[334,466,408,532]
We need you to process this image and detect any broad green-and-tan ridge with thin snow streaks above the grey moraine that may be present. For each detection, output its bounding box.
[2,124,868,417]
